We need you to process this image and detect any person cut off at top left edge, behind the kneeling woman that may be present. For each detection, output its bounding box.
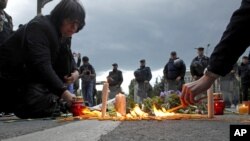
[0,0,13,45]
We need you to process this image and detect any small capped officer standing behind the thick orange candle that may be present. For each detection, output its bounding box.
[107,63,123,99]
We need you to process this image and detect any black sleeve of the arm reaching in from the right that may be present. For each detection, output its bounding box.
[208,0,250,76]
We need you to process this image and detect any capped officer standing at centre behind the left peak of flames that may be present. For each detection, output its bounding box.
[134,59,152,103]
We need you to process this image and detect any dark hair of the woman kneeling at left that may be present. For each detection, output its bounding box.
[50,0,86,32]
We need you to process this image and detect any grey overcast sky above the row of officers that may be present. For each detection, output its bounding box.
[6,0,249,92]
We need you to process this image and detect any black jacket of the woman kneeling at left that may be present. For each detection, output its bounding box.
[0,16,74,96]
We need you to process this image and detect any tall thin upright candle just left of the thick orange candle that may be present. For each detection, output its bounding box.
[102,82,109,117]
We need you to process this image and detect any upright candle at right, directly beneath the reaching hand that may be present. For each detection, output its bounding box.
[207,88,214,118]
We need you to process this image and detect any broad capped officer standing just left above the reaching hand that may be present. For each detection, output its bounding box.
[163,51,186,91]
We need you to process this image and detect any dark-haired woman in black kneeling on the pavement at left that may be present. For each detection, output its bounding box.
[0,0,85,118]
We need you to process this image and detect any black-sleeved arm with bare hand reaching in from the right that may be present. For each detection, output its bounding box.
[181,0,250,105]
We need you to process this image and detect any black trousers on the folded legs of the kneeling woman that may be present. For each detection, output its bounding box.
[0,78,60,118]
